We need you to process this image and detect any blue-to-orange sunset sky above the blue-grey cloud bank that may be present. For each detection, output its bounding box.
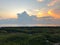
[0,0,60,19]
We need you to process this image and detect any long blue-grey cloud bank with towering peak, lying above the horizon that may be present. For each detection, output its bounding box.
[0,12,60,26]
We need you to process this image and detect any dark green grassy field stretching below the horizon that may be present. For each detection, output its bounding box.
[0,27,60,45]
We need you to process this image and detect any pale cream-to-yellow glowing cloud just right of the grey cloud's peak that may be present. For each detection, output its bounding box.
[28,8,48,17]
